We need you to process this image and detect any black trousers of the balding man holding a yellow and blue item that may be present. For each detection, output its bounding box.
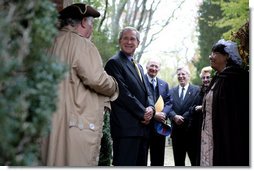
[149,131,166,166]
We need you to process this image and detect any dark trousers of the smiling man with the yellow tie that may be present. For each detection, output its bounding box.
[112,137,148,166]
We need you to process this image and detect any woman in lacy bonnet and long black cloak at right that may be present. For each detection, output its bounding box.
[200,39,249,166]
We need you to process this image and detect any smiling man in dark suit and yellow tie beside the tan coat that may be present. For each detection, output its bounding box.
[105,27,154,166]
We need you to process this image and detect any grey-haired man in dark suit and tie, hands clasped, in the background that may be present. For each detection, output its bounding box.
[169,67,199,166]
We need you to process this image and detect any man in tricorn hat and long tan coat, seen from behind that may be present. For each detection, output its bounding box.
[41,3,118,166]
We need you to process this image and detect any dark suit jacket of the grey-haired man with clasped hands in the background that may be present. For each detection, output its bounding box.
[169,84,200,130]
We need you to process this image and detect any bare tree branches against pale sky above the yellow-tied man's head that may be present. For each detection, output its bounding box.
[99,0,185,61]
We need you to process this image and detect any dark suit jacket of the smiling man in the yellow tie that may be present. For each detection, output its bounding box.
[105,51,154,137]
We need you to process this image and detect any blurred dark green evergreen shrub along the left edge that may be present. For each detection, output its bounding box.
[0,0,66,166]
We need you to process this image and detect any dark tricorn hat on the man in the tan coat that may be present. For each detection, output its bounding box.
[59,3,100,20]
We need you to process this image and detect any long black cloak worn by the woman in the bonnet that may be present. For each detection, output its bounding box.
[201,66,249,166]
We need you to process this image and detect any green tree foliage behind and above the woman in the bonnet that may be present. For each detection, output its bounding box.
[194,0,249,84]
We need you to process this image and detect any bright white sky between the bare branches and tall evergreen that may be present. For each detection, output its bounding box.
[140,0,201,68]
